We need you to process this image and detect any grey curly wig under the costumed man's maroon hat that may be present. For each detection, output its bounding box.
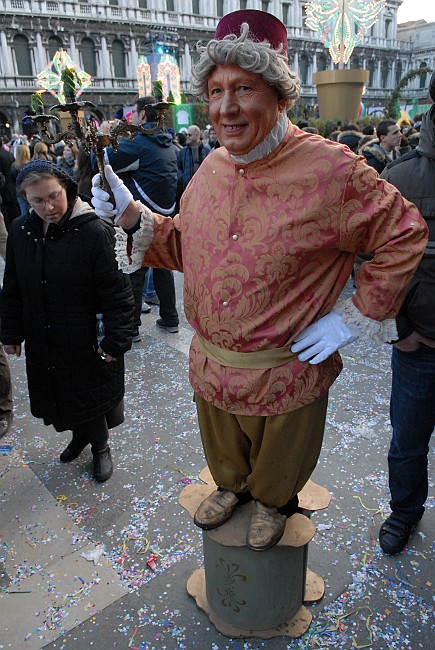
[191,23,300,110]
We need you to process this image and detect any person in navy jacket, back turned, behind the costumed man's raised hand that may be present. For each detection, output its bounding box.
[106,95,179,342]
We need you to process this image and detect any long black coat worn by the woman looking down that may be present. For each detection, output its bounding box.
[1,199,134,431]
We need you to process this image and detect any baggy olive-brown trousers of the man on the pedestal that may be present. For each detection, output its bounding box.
[195,394,328,508]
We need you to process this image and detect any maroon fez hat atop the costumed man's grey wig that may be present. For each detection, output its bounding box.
[214,9,288,55]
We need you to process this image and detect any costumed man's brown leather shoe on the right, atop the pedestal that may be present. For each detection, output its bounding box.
[246,501,287,551]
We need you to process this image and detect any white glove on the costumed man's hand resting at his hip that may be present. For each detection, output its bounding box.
[290,311,359,364]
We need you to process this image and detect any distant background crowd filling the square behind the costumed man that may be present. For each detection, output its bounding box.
[0,113,423,230]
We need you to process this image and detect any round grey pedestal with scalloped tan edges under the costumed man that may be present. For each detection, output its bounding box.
[179,470,330,639]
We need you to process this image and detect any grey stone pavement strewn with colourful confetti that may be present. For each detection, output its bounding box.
[0,274,435,650]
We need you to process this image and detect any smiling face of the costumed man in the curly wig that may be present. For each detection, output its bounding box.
[208,65,285,156]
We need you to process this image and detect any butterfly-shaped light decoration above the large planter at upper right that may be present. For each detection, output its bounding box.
[305,0,386,67]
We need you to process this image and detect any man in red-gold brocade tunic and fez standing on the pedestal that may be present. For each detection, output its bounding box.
[93,10,427,551]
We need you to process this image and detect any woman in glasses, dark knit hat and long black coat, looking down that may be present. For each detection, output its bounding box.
[1,160,134,481]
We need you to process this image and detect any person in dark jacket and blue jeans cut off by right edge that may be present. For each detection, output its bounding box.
[379,74,435,555]
